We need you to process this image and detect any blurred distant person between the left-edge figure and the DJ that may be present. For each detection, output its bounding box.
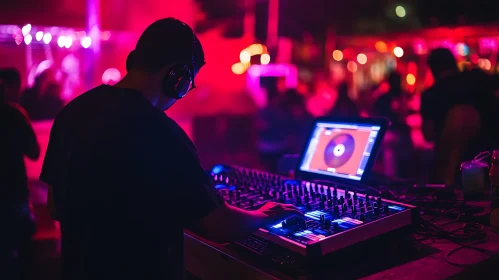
[21,69,64,120]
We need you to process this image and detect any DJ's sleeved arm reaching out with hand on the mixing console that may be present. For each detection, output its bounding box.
[161,117,301,243]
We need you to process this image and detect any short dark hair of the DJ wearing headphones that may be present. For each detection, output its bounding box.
[131,18,205,73]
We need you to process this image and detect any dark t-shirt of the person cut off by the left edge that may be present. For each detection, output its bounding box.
[0,101,39,203]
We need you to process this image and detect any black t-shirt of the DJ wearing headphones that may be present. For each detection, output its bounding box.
[40,85,220,279]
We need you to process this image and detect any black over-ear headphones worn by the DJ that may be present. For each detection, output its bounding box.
[126,23,196,99]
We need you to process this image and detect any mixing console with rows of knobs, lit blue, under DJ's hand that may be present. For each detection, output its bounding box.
[211,165,419,266]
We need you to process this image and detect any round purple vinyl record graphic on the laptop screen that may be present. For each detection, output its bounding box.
[324,133,355,168]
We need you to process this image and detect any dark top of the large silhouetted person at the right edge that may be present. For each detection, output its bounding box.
[421,70,497,160]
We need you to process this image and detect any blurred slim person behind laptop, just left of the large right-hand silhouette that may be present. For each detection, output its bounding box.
[374,72,414,178]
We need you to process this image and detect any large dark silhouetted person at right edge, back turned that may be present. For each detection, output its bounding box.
[420,48,498,186]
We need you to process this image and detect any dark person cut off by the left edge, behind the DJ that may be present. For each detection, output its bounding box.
[0,68,40,279]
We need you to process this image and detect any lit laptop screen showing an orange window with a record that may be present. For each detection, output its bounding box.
[298,120,383,181]
